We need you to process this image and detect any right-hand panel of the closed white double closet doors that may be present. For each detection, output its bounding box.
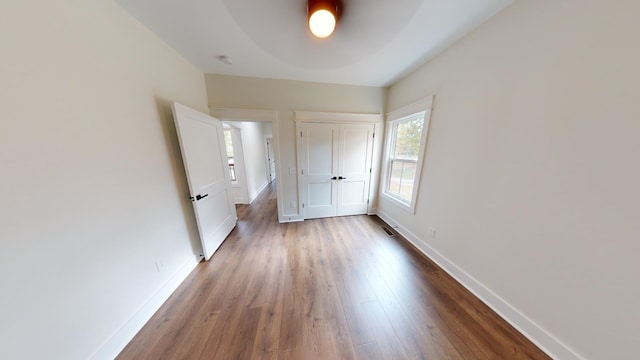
[336,124,374,216]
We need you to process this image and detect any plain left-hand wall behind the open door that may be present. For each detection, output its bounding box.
[0,0,207,359]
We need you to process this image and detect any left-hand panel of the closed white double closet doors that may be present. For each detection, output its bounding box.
[301,123,338,219]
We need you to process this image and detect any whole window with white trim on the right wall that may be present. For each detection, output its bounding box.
[382,99,431,211]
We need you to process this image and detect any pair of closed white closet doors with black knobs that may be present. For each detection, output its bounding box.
[300,123,375,219]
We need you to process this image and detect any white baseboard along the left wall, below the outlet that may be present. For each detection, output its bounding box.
[90,258,198,360]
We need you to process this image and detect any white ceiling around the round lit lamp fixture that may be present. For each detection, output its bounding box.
[115,0,514,86]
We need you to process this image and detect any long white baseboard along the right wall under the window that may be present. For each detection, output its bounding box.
[377,209,584,360]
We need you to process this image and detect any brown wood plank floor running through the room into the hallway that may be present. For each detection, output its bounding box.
[118,184,549,360]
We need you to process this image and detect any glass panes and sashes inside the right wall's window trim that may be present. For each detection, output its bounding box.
[387,113,424,203]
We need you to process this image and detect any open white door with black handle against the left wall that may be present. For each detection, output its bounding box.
[172,102,237,260]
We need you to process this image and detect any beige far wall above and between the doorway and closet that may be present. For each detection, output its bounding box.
[205,74,384,221]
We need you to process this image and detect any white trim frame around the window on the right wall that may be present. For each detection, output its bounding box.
[381,96,433,214]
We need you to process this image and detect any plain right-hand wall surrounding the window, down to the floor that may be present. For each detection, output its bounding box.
[379,0,640,359]
